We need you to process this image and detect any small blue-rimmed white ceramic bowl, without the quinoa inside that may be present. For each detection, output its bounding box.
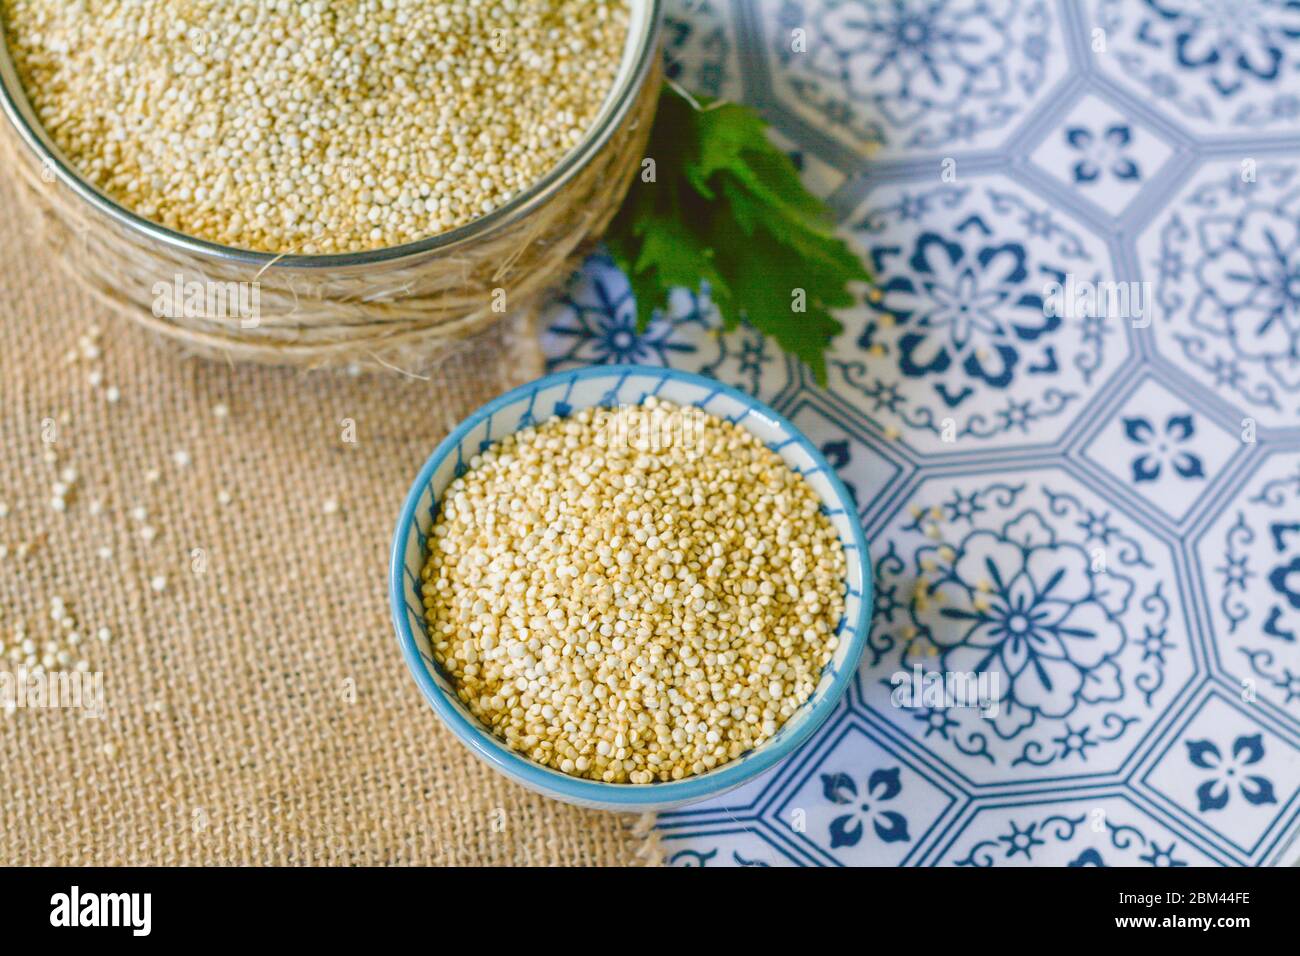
[389,365,871,812]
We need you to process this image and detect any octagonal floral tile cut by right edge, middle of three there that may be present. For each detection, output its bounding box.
[1138,160,1300,428]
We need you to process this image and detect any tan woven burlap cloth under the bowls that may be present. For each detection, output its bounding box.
[0,170,660,865]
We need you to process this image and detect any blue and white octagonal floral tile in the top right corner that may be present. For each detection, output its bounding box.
[1084,0,1300,137]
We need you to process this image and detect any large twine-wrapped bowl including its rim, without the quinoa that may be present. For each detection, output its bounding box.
[0,0,660,371]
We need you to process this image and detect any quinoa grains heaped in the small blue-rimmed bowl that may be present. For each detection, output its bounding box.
[423,397,845,783]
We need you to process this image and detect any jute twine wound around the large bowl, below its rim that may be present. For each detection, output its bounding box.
[0,57,660,369]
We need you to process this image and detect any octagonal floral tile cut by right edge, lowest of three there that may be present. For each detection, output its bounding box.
[1196,453,1300,732]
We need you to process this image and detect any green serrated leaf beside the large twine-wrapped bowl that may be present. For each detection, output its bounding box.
[606,87,871,384]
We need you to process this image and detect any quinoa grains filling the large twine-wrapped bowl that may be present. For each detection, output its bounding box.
[0,0,628,254]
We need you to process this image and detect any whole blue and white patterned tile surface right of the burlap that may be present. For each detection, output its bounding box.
[545,0,1300,866]
